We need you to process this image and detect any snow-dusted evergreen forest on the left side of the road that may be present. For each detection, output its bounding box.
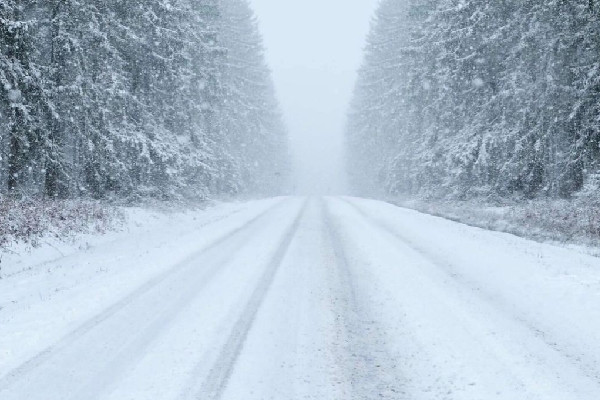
[0,0,289,201]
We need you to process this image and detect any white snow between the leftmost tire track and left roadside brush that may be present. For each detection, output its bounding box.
[0,199,277,380]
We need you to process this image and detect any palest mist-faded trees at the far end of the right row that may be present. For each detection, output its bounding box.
[346,0,409,195]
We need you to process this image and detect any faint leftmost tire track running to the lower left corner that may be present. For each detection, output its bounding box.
[0,200,286,391]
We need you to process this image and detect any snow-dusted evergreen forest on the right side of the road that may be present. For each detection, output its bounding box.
[346,0,600,200]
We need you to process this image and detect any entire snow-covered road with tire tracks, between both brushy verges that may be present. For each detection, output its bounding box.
[0,198,600,400]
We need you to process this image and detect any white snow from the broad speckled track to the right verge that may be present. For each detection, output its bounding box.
[336,199,600,400]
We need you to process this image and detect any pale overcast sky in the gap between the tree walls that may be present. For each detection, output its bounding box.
[250,0,378,194]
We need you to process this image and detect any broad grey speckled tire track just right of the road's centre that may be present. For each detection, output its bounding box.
[321,200,405,400]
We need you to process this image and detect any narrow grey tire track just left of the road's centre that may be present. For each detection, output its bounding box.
[196,201,308,400]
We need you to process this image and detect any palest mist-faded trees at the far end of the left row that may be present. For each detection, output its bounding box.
[220,0,288,194]
